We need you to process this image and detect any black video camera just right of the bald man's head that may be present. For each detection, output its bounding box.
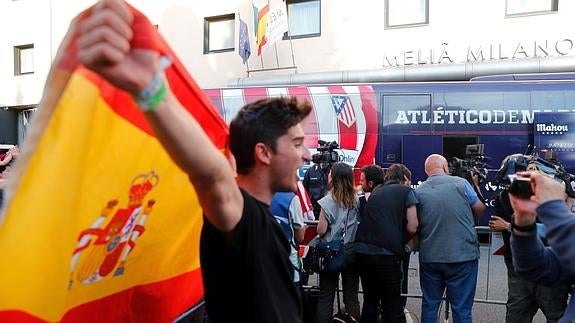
[448,144,491,185]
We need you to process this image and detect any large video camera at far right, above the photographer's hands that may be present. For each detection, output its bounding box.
[493,149,575,198]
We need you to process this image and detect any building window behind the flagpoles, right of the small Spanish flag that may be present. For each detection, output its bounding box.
[284,0,321,38]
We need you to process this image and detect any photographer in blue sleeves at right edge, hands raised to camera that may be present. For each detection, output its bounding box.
[509,172,575,322]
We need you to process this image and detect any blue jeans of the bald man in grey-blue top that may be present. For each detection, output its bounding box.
[419,260,479,323]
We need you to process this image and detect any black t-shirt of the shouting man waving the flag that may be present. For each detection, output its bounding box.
[200,190,303,323]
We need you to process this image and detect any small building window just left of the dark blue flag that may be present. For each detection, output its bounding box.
[204,14,235,54]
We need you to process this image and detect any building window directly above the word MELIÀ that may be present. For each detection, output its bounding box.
[385,0,429,28]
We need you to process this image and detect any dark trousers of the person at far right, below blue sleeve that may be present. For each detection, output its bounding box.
[505,259,570,323]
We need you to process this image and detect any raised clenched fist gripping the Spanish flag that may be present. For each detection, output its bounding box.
[77,0,159,95]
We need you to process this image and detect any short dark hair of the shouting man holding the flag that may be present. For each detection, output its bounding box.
[230,97,311,174]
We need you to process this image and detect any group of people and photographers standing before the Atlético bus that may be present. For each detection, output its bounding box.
[296,154,575,323]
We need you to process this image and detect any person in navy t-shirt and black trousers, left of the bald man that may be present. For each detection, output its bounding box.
[355,164,418,322]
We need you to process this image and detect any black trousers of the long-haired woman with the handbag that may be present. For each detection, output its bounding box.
[315,264,360,323]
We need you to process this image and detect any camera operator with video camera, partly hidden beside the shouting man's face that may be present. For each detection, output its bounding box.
[302,140,339,220]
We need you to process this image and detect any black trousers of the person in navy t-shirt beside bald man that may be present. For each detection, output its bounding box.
[357,254,404,323]
